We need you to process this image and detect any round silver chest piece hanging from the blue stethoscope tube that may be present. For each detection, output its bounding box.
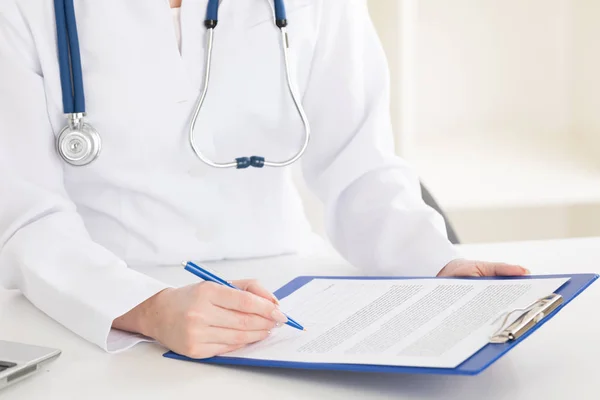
[56,114,102,166]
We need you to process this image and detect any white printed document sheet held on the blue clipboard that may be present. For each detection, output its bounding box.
[224,278,568,368]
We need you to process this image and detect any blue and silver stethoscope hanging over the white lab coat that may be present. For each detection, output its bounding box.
[54,0,310,169]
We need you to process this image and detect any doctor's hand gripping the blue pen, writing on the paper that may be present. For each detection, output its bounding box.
[113,280,287,359]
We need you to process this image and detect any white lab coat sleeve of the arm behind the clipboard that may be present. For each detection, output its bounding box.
[303,0,460,276]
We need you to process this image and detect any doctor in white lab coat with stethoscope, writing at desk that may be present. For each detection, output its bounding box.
[0,0,526,358]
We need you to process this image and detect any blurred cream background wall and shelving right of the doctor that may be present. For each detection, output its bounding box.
[369,0,600,243]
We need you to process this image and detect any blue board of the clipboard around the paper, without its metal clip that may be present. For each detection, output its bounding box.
[164,274,599,376]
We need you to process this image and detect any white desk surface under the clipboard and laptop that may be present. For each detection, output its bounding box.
[0,238,600,400]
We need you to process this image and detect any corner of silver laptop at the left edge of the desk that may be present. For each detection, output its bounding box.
[0,340,61,389]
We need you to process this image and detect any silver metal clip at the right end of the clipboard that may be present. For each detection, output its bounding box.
[490,293,564,344]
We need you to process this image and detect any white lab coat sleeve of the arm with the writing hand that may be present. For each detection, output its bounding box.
[0,2,166,352]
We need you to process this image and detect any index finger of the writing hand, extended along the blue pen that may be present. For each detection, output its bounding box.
[209,285,287,324]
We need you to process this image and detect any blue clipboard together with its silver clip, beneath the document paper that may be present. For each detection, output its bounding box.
[163,274,599,376]
